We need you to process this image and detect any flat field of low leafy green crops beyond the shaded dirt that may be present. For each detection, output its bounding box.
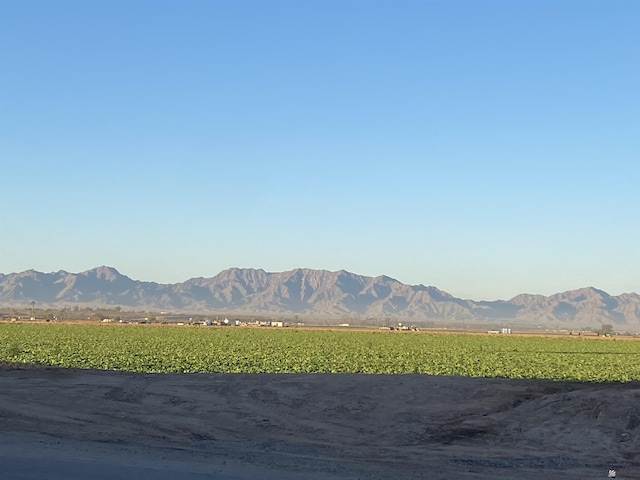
[0,324,640,381]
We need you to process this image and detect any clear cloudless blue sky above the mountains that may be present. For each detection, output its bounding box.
[0,0,640,299]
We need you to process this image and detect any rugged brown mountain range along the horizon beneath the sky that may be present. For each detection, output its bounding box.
[0,266,640,331]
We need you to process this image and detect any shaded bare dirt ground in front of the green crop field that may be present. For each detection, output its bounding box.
[0,364,640,480]
